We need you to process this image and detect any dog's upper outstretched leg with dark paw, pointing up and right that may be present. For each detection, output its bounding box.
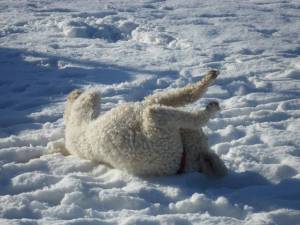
[145,70,219,107]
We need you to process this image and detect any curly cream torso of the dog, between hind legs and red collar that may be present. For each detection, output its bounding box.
[88,103,182,175]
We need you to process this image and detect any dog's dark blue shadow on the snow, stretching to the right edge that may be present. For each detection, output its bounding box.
[149,171,300,212]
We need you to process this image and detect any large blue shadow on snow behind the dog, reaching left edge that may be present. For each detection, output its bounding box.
[0,47,178,136]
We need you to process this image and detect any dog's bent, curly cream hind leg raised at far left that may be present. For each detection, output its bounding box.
[69,91,100,125]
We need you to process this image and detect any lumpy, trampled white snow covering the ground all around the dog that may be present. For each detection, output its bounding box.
[0,0,300,225]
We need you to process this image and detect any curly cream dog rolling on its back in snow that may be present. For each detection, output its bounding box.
[56,70,227,177]
